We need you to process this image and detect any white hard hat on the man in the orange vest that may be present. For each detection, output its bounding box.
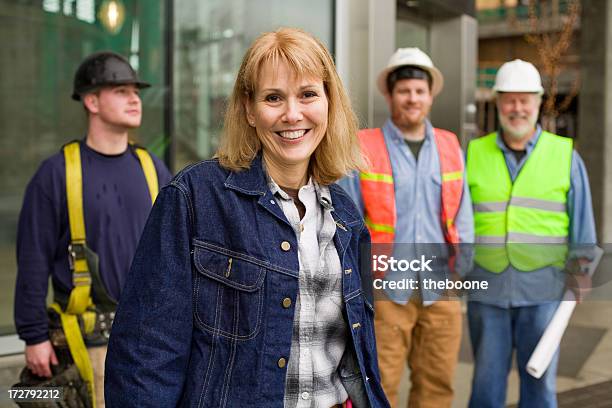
[376,47,444,96]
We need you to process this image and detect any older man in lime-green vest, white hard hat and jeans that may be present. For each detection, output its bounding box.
[467,60,596,408]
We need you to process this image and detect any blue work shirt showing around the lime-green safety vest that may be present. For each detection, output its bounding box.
[470,125,597,308]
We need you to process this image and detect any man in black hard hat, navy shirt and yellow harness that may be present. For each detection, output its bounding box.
[15,51,171,408]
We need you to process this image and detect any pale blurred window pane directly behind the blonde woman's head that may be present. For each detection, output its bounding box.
[173,0,334,170]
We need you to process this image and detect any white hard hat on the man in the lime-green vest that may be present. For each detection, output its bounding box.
[493,59,544,95]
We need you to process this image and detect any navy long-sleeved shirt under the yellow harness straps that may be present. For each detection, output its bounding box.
[15,142,171,344]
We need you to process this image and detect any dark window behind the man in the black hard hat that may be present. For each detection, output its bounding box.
[0,0,166,342]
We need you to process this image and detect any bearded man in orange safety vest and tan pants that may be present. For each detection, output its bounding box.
[341,48,473,407]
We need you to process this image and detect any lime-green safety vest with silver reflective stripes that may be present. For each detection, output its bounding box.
[467,132,573,272]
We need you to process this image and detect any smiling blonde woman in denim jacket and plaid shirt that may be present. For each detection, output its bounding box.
[105,29,388,408]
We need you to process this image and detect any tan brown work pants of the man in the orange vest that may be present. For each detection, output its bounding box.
[374,299,461,408]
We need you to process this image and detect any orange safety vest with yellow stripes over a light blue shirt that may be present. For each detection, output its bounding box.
[358,128,464,244]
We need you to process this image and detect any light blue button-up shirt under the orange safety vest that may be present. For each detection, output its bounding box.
[339,119,474,304]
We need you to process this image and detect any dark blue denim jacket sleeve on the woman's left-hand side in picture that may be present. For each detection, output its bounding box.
[105,181,192,408]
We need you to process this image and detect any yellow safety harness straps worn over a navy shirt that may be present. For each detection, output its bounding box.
[51,141,159,408]
